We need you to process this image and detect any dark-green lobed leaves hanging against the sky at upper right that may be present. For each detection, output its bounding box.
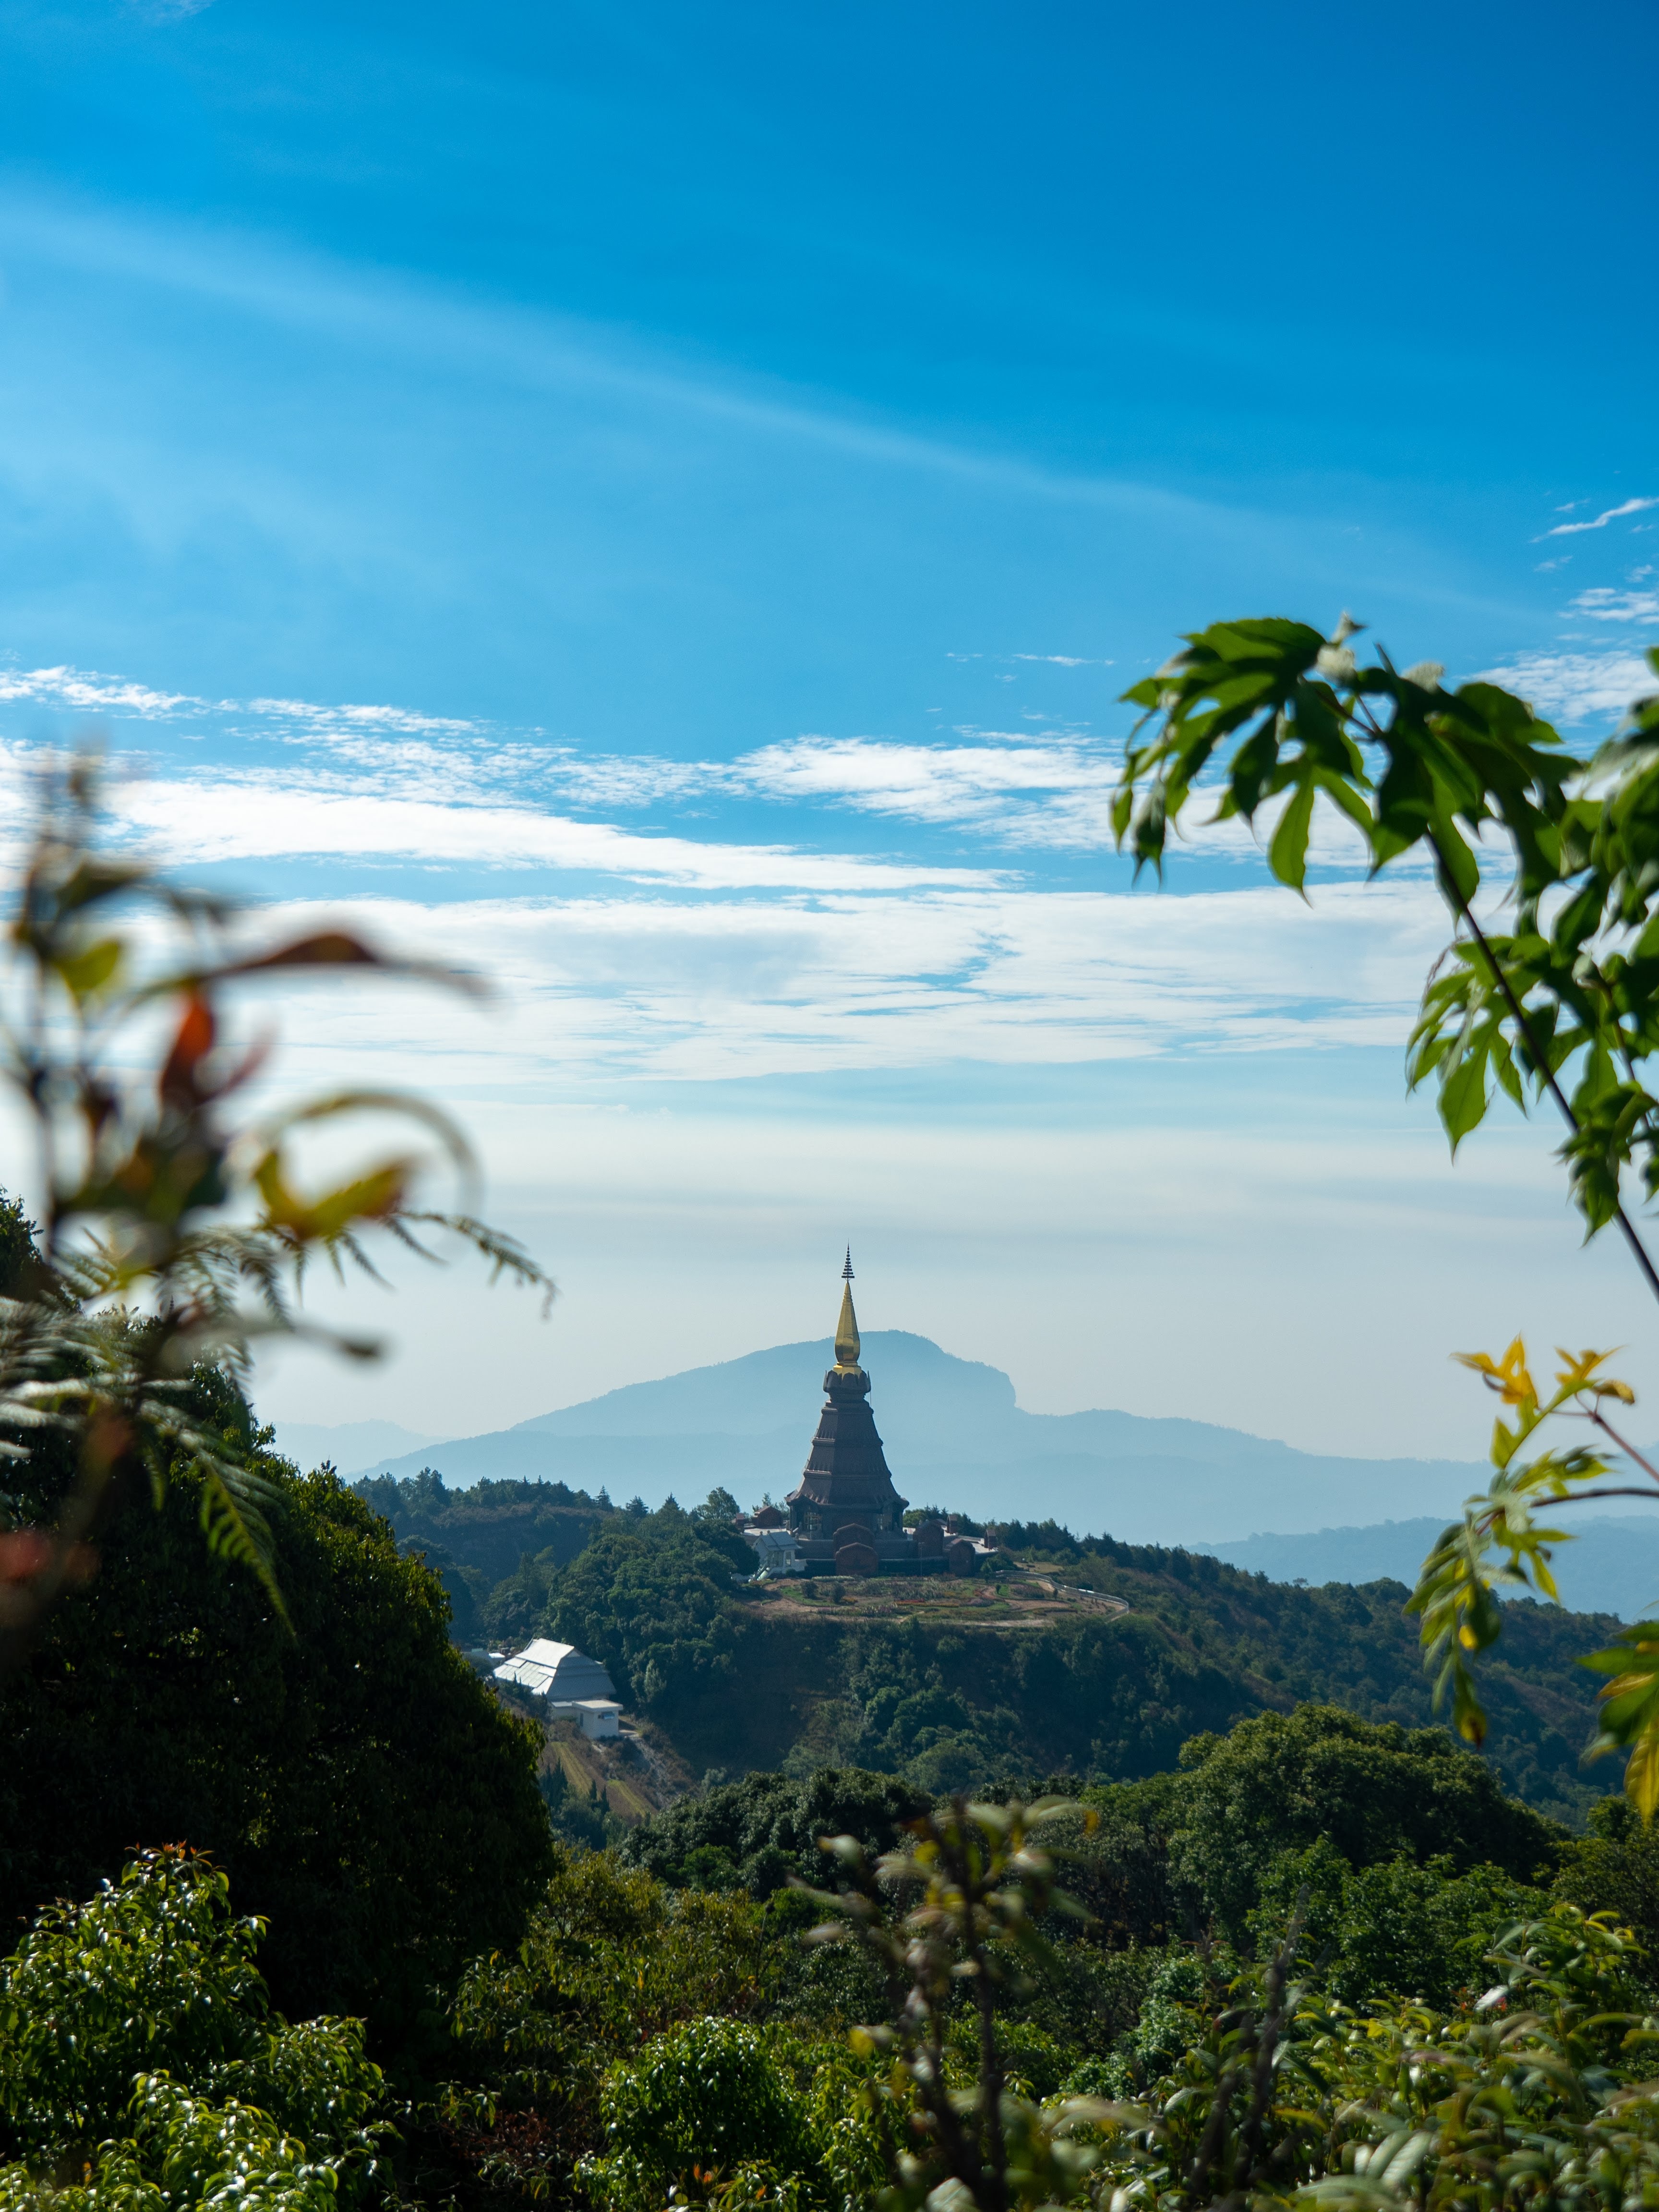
[1113,615,1659,1296]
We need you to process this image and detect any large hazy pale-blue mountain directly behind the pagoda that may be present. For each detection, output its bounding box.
[354,1329,1482,1546]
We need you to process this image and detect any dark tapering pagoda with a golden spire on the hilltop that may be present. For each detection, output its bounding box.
[785,1248,942,1575]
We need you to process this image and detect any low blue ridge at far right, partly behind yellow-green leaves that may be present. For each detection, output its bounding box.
[1194,1513,1659,1622]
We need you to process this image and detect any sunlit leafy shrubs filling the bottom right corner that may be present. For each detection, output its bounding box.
[1083,1904,1659,2212]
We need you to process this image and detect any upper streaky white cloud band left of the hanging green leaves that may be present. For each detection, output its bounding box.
[0,668,1363,863]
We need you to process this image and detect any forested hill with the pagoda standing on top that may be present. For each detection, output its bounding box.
[358,1478,1619,1823]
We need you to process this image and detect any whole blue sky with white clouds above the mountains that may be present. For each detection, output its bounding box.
[0,0,1659,1468]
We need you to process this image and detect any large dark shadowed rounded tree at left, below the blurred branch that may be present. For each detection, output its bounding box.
[0,1407,551,2051]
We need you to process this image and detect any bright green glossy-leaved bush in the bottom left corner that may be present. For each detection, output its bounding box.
[0,1849,387,2212]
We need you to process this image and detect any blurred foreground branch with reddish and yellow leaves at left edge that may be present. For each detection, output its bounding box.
[0,761,553,1674]
